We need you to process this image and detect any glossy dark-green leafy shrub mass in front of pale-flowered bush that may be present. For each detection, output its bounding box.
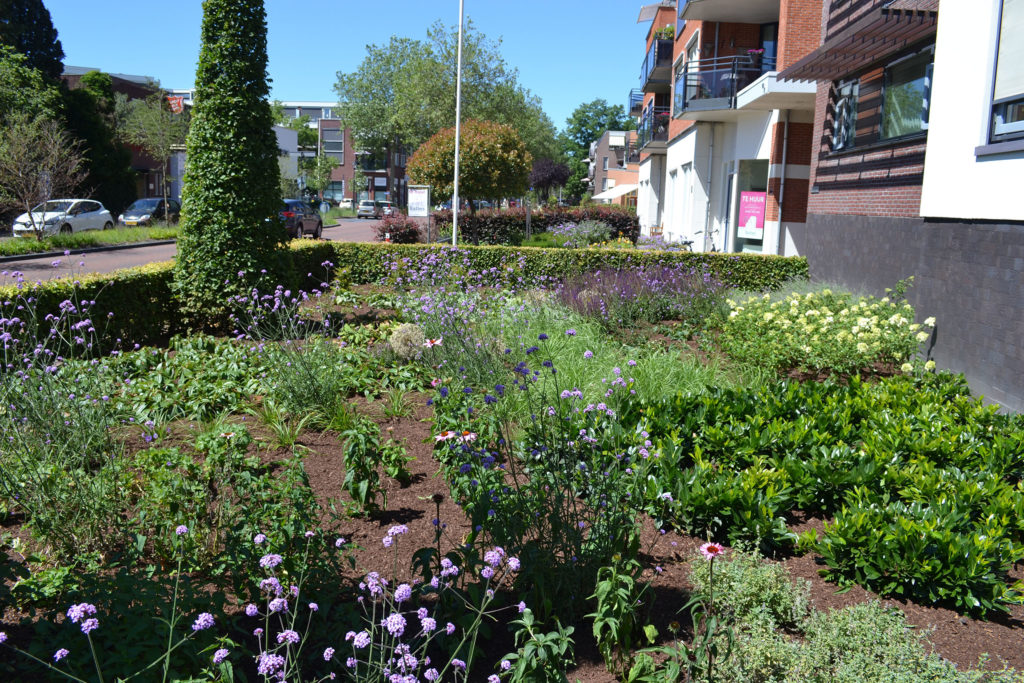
[638,374,1024,612]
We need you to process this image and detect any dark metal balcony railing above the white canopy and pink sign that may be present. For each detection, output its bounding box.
[675,54,775,117]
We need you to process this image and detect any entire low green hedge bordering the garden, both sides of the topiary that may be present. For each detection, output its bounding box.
[0,240,808,350]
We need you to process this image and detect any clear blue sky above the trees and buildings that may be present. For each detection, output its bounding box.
[44,0,650,129]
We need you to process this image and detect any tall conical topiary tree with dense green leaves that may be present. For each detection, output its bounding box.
[174,0,285,325]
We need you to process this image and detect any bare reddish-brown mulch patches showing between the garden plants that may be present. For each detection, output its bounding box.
[0,394,1024,683]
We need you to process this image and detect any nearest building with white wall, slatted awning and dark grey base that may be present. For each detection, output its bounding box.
[779,0,1024,411]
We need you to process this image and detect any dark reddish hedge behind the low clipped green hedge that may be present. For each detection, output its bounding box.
[433,205,640,245]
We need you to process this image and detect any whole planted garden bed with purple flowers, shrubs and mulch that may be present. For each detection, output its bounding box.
[0,258,1024,681]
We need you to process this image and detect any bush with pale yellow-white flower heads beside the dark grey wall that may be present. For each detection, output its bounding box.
[718,289,935,374]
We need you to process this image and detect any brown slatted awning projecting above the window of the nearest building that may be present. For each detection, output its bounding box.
[778,0,939,81]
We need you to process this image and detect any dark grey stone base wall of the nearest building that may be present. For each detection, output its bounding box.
[794,214,1024,412]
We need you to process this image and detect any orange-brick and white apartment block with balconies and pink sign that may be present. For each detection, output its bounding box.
[630,0,821,254]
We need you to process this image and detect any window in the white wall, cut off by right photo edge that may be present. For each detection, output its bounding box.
[991,0,1024,142]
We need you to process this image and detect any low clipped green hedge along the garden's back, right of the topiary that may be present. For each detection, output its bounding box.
[317,242,808,291]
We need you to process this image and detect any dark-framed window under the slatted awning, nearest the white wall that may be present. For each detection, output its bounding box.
[882,47,934,140]
